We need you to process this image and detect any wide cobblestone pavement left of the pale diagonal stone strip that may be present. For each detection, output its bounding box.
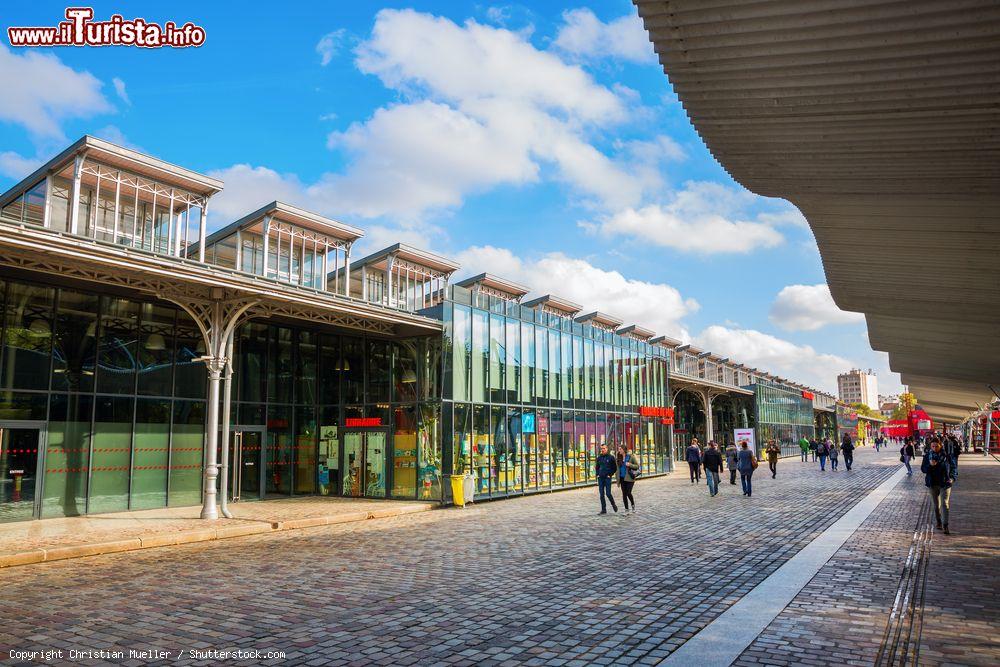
[0,450,995,665]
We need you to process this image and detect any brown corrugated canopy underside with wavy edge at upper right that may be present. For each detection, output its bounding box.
[635,0,1000,421]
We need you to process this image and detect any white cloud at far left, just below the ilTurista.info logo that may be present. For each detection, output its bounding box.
[0,45,113,140]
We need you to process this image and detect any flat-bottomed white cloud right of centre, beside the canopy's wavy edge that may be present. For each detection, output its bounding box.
[581,182,784,254]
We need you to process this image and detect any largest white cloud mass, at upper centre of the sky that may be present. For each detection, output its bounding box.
[210,10,656,222]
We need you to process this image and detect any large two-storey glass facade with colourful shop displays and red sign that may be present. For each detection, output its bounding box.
[435,286,671,498]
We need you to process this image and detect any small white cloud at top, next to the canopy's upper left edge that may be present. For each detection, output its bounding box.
[553,9,656,64]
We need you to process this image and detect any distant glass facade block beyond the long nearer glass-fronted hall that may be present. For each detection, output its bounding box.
[753,380,815,456]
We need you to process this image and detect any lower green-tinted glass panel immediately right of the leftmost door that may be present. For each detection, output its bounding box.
[42,394,94,518]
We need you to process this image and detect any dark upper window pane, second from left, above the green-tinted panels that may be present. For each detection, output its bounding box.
[52,289,99,392]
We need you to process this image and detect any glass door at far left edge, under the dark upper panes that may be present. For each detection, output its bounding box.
[0,423,42,522]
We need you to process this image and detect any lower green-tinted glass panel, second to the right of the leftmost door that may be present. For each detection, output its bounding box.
[88,396,135,513]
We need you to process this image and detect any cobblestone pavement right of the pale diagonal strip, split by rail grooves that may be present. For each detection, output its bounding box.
[735,456,1000,667]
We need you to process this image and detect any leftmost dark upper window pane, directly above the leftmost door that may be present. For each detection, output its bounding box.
[0,282,55,389]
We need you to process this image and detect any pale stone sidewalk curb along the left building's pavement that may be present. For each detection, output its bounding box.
[0,505,438,569]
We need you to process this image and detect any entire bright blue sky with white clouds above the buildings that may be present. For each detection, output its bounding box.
[0,0,899,393]
